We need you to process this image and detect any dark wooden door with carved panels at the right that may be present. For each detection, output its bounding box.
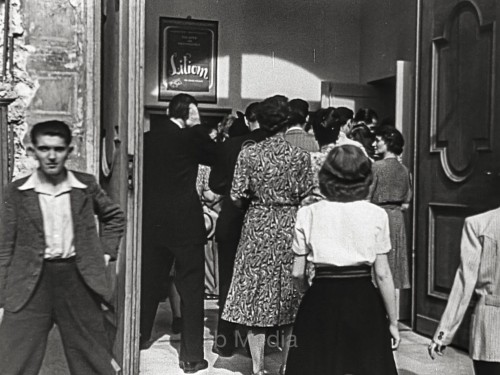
[415,0,500,347]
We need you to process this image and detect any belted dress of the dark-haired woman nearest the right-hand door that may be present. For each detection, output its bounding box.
[370,158,412,289]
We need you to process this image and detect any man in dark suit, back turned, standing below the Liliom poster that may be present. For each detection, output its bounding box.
[141,94,216,373]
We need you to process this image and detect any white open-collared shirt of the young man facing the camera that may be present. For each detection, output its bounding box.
[19,171,87,259]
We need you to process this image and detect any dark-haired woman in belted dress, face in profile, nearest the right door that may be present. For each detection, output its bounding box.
[369,126,412,289]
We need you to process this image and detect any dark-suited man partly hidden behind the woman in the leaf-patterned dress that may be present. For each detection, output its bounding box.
[209,103,267,357]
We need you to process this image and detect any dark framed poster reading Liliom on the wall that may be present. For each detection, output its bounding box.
[158,17,218,103]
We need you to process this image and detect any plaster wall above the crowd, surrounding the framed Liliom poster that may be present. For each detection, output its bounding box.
[145,0,360,109]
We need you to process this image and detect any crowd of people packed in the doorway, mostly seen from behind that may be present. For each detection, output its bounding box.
[141,94,412,375]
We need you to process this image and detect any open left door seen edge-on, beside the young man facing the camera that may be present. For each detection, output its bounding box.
[100,0,144,374]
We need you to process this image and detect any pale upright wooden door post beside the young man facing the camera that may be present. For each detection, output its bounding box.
[121,0,146,374]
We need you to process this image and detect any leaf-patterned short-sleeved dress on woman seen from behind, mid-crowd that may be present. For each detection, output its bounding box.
[222,135,312,327]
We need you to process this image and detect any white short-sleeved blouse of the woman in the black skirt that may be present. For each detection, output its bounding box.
[292,200,391,267]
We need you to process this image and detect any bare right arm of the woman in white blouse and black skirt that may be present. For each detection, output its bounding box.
[374,254,401,349]
